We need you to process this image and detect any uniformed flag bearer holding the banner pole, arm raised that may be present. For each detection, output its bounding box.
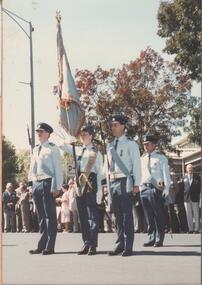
[60,125,103,255]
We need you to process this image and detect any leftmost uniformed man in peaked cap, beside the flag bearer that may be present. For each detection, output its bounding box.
[28,123,63,255]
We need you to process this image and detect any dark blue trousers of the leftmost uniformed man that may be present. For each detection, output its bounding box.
[32,178,57,251]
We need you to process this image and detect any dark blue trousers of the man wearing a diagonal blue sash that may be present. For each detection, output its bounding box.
[110,178,134,251]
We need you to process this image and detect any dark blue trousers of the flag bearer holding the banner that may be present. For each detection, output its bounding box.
[76,191,99,247]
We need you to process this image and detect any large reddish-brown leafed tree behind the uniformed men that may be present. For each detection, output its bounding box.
[76,47,195,151]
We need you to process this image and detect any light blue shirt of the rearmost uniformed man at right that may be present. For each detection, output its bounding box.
[140,151,171,194]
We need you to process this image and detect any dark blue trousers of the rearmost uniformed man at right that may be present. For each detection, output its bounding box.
[140,187,165,243]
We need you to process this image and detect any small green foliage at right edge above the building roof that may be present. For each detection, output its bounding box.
[184,100,201,145]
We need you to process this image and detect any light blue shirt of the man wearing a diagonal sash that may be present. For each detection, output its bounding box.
[105,135,141,186]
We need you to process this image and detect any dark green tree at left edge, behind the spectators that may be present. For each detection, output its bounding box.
[2,137,18,189]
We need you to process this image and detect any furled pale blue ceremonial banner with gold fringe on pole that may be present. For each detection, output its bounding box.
[56,12,85,137]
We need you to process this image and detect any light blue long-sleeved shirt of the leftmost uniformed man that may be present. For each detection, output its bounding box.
[28,141,63,192]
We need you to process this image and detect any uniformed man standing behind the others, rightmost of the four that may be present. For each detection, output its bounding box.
[140,135,171,247]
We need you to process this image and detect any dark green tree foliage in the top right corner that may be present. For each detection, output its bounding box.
[157,0,202,81]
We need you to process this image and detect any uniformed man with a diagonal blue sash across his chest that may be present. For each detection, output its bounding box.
[105,115,141,256]
